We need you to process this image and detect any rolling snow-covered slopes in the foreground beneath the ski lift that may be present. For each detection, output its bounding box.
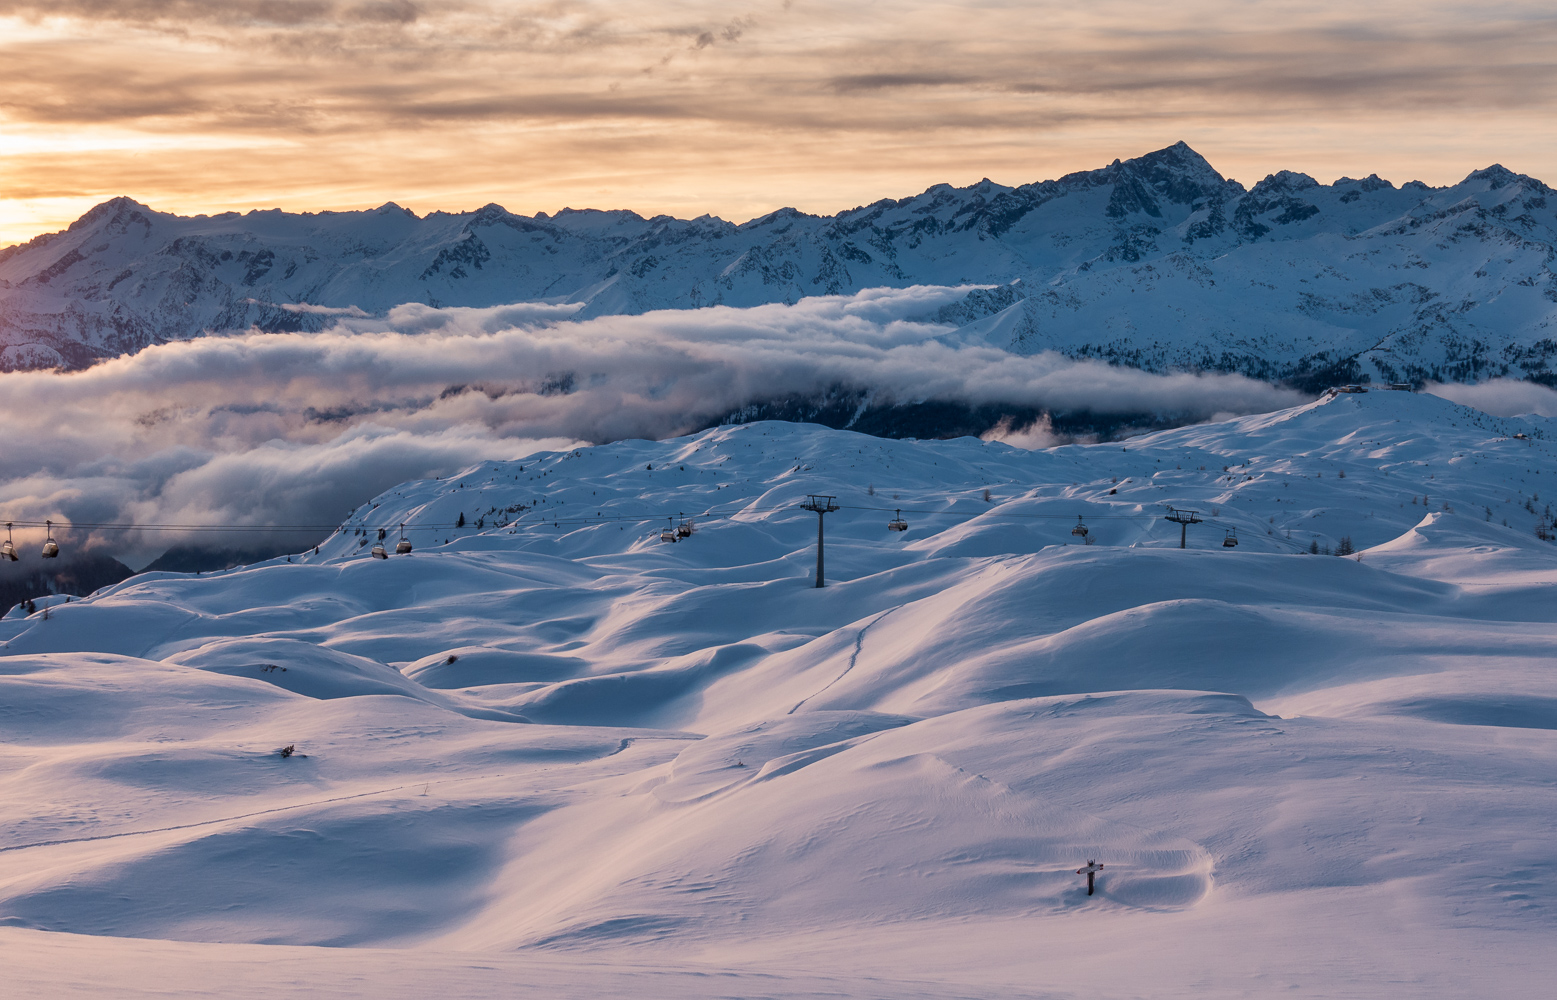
[0,391,1557,997]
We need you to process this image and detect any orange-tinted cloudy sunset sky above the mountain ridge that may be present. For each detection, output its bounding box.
[0,0,1557,246]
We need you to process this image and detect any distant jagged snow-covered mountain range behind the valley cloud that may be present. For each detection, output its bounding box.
[0,143,1557,385]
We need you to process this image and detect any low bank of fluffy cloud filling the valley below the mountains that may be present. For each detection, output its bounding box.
[0,287,1303,564]
